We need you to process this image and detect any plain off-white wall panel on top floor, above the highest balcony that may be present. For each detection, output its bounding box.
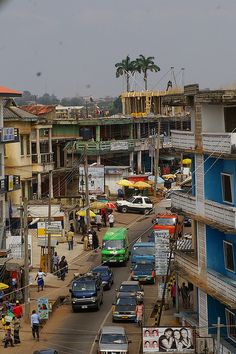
[202,104,225,133]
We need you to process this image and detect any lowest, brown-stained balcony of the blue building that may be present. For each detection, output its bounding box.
[175,251,236,308]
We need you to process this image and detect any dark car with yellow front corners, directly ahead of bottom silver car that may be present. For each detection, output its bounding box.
[112,292,137,322]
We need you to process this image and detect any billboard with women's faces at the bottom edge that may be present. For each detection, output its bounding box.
[142,327,195,353]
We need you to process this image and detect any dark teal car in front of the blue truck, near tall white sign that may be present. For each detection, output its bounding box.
[131,263,156,284]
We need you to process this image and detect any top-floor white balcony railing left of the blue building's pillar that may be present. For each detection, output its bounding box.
[171,130,195,151]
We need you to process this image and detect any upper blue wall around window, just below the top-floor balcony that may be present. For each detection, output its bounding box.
[204,156,236,206]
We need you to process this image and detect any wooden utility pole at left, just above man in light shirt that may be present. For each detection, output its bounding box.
[23,198,30,322]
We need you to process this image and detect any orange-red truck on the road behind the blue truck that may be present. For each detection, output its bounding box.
[152,214,183,237]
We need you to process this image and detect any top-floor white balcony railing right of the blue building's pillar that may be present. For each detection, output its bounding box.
[202,133,236,154]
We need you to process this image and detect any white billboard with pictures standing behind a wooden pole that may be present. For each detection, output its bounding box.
[79,166,105,194]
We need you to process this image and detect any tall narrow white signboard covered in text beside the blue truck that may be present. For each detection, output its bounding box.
[154,230,170,275]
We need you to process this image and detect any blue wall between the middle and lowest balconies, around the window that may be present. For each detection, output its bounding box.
[206,225,236,280]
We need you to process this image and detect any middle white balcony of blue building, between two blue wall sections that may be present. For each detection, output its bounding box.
[171,192,236,232]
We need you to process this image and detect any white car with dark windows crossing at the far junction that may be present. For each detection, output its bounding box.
[116,195,153,214]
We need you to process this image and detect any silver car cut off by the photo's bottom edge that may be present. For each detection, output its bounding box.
[96,326,131,354]
